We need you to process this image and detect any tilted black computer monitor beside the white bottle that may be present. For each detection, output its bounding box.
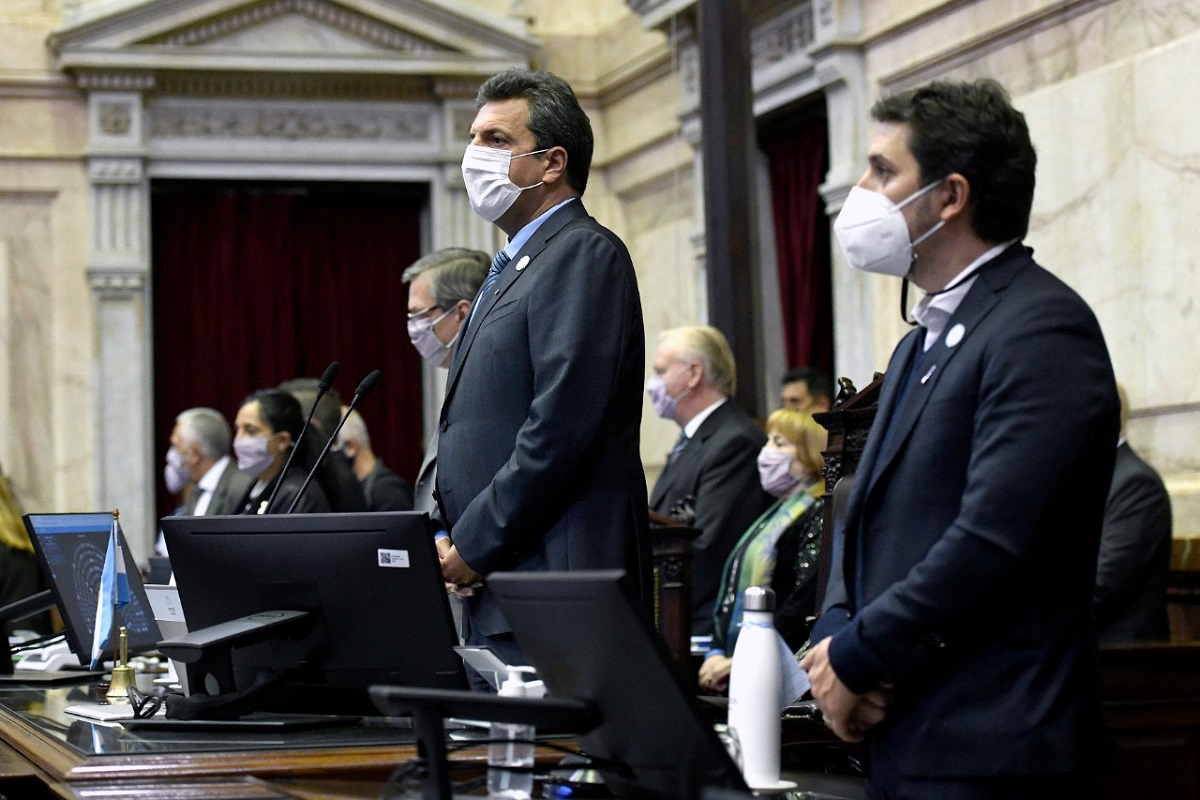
[487,570,749,800]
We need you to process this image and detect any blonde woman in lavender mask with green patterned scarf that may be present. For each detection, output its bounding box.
[700,408,828,692]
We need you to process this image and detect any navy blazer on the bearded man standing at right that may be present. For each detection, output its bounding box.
[814,245,1118,776]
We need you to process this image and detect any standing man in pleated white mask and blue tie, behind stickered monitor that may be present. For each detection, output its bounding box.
[438,68,650,687]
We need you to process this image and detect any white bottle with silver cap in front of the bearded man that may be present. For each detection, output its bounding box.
[730,587,782,789]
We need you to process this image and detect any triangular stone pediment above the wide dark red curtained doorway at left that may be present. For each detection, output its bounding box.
[48,0,536,77]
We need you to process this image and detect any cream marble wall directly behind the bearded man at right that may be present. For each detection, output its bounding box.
[864,0,1200,539]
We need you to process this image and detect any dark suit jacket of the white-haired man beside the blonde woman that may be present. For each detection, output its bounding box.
[650,398,772,634]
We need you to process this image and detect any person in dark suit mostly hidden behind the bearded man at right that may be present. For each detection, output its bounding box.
[1093,385,1171,643]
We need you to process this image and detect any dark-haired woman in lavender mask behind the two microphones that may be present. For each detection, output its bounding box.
[233,389,330,513]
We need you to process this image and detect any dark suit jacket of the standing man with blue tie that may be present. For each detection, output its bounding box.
[437,200,650,636]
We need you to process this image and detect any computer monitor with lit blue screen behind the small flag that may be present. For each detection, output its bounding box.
[23,511,162,666]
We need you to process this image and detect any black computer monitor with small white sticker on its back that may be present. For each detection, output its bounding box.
[162,511,466,714]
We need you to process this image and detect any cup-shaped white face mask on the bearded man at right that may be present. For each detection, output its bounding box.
[833,181,946,278]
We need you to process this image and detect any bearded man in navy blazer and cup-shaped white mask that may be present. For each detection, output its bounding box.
[802,80,1118,799]
